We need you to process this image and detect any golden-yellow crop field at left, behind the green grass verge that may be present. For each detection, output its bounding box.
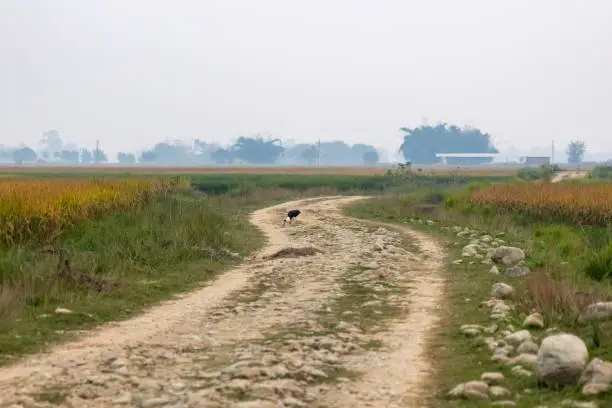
[0,178,188,244]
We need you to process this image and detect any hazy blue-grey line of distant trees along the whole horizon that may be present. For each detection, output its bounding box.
[0,123,586,166]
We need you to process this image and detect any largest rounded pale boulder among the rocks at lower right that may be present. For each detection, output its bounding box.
[536,333,589,388]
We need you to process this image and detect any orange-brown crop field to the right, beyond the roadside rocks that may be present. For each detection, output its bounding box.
[470,183,612,226]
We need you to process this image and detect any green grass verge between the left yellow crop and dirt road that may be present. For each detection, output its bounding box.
[0,189,344,365]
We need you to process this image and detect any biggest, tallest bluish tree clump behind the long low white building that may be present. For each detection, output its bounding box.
[400,123,499,165]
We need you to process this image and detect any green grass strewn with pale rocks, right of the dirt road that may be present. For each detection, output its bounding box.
[347,191,612,407]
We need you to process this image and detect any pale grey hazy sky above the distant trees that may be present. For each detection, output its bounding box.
[0,0,612,156]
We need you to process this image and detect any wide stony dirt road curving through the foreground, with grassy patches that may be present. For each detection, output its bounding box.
[0,197,442,408]
